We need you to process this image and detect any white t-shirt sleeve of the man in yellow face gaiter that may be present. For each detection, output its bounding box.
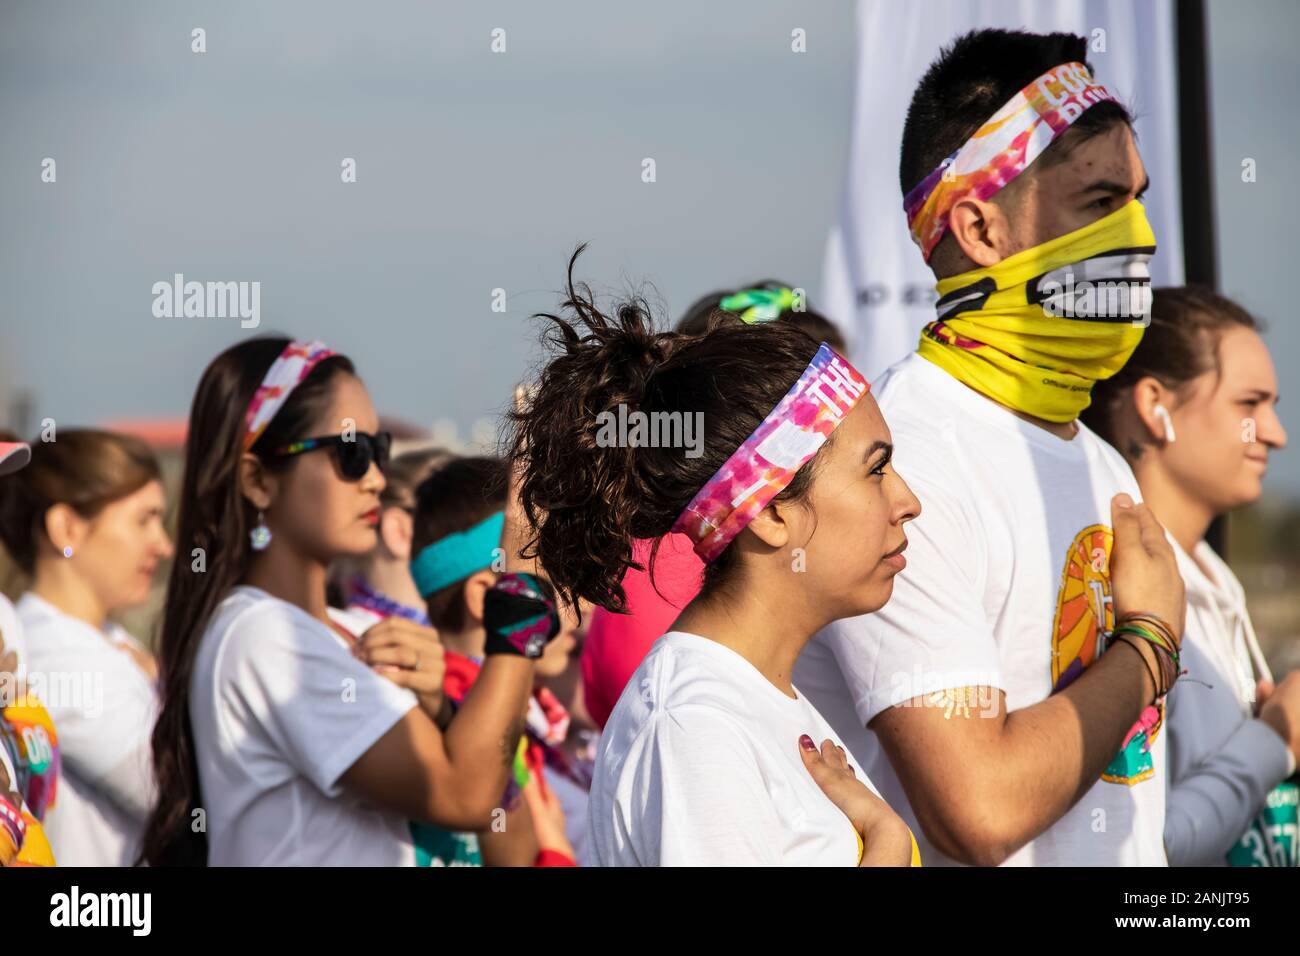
[822,460,1002,724]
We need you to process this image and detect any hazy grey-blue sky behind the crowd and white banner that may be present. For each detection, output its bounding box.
[0,0,1300,497]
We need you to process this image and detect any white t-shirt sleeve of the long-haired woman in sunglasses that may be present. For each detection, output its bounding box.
[216,601,417,797]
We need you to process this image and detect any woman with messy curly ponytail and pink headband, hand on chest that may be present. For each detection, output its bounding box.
[514,250,919,865]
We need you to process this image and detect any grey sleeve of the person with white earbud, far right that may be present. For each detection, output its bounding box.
[1165,721,1291,866]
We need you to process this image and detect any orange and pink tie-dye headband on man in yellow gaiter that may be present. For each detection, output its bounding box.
[902,62,1118,263]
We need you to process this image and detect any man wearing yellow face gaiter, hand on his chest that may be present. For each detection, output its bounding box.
[794,30,1184,866]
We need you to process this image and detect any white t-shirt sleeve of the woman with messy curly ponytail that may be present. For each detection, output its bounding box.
[619,706,784,866]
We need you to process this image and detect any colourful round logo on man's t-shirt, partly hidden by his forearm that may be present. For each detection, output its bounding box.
[1052,524,1165,787]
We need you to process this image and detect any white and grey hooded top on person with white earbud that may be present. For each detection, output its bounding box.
[1165,541,1295,866]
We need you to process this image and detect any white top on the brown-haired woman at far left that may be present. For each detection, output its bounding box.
[18,592,159,866]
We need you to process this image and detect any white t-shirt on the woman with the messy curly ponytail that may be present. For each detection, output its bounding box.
[589,631,870,866]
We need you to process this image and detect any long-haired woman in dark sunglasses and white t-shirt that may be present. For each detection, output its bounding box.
[143,338,546,865]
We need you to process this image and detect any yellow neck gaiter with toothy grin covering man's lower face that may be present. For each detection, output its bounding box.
[917,199,1156,421]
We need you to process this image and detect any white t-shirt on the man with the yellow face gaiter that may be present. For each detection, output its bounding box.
[794,354,1167,866]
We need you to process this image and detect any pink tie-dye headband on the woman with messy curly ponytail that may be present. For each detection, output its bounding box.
[672,342,871,563]
